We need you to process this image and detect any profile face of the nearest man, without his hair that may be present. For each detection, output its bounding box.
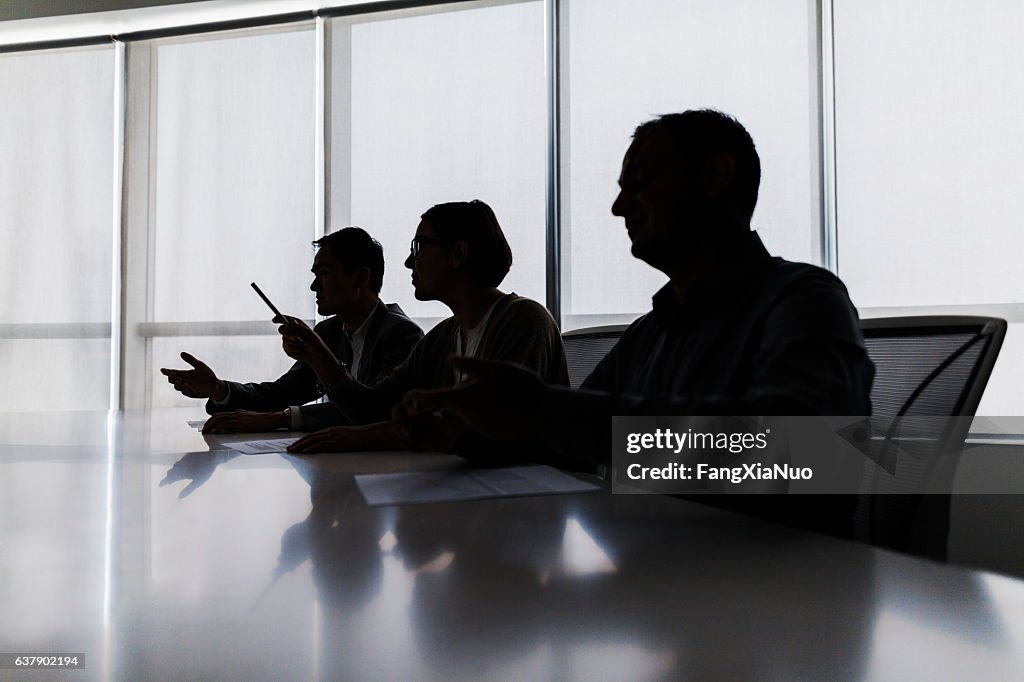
[611,129,702,271]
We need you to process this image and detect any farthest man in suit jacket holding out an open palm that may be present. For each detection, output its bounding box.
[161,227,423,432]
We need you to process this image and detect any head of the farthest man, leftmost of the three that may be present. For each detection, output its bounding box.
[309,227,384,316]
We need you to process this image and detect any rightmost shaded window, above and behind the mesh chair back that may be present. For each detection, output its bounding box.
[835,0,1024,415]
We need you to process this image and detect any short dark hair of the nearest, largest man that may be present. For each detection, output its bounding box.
[633,109,761,219]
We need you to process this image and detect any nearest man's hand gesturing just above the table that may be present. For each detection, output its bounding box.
[395,356,547,438]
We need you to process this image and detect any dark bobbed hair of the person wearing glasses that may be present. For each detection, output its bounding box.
[420,199,512,287]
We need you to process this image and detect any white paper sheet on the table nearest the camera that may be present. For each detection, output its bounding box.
[355,466,600,507]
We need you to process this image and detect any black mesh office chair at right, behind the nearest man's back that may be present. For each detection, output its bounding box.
[859,315,1007,559]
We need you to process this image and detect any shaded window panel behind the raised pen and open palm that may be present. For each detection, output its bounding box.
[126,25,317,407]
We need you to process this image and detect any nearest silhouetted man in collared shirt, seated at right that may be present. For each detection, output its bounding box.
[403,111,873,535]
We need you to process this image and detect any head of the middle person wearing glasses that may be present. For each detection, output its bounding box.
[406,200,512,300]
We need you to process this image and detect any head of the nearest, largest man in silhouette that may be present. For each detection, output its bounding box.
[611,110,761,271]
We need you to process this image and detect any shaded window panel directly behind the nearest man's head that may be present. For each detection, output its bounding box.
[561,0,820,329]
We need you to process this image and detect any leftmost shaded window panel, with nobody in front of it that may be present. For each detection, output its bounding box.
[0,46,115,412]
